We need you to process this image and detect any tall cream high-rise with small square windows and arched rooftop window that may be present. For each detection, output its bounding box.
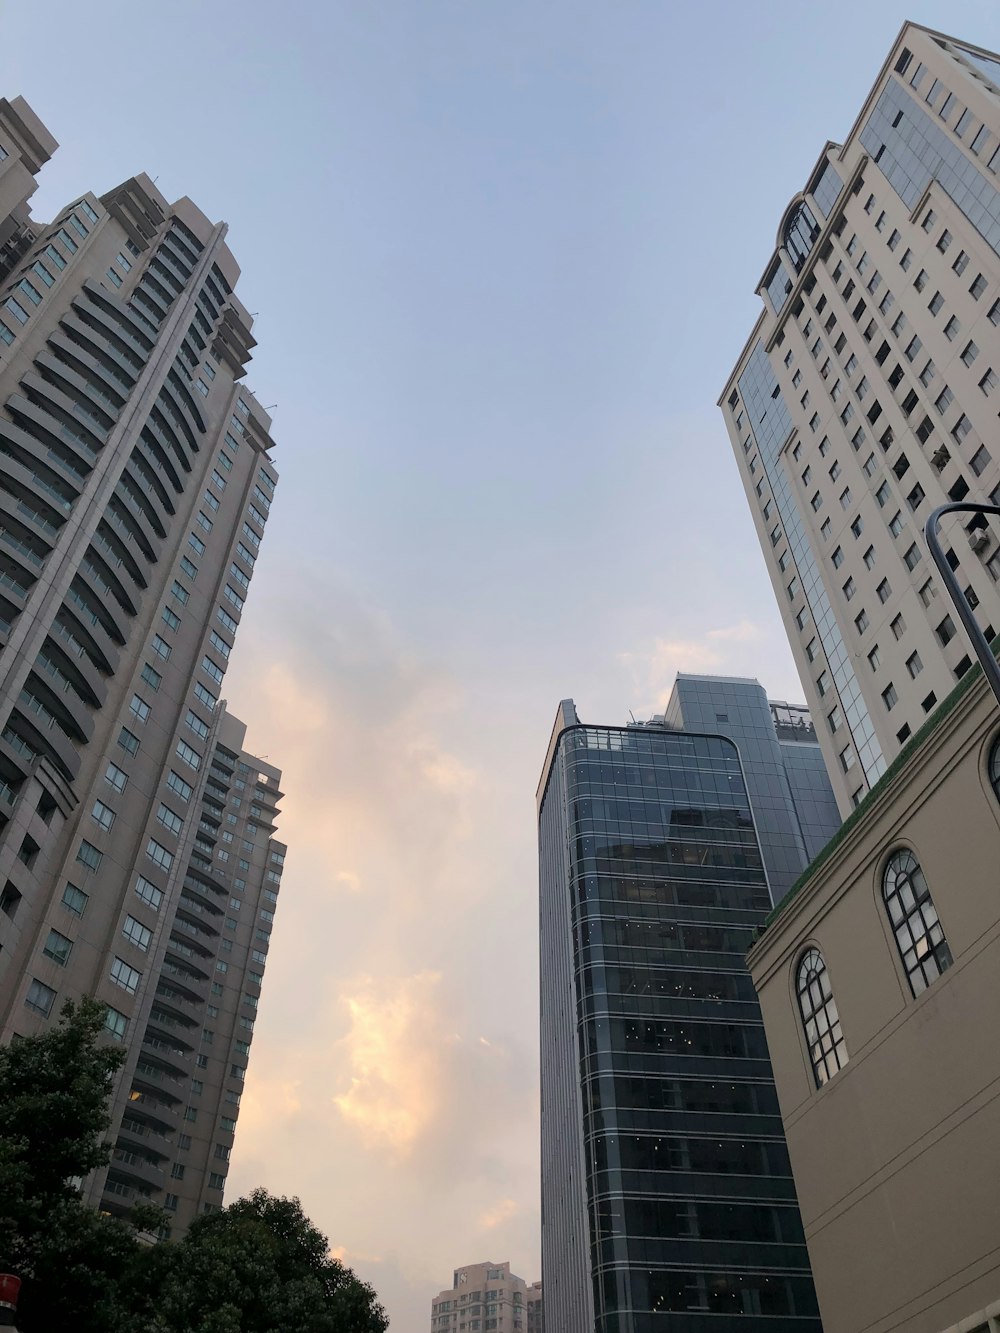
[720,23,1000,813]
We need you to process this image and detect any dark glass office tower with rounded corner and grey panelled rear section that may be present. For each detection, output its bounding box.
[539,677,839,1333]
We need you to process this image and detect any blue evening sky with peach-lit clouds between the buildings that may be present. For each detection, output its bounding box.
[0,0,1000,1333]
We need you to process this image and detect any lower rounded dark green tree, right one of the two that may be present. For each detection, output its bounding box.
[149,1189,388,1333]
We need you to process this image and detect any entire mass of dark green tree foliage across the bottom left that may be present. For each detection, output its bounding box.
[0,1000,388,1333]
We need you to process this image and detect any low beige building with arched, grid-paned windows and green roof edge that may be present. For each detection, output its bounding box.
[748,668,1000,1333]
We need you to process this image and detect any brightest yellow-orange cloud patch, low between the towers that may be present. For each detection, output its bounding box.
[333,972,441,1156]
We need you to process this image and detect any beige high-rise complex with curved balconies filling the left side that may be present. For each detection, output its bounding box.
[0,99,284,1226]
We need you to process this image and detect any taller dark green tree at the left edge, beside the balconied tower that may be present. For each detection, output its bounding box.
[0,1000,139,1333]
